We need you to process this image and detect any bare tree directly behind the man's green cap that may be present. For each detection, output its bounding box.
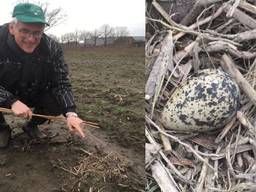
[14,0,67,31]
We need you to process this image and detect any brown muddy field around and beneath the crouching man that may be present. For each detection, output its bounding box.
[0,48,144,192]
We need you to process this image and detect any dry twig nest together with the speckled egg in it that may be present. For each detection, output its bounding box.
[145,0,256,192]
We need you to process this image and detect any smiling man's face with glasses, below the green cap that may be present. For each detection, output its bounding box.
[9,21,44,53]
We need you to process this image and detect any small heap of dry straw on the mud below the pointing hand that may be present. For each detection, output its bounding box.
[55,148,129,191]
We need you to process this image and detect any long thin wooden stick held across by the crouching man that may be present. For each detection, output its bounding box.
[0,107,99,128]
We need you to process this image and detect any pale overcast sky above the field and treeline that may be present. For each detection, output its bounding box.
[0,0,145,37]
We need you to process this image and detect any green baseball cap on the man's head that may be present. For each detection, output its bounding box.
[12,3,49,25]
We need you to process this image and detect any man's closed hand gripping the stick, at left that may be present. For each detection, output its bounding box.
[11,100,32,119]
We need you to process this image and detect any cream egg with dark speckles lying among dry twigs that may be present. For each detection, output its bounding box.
[161,69,240,132]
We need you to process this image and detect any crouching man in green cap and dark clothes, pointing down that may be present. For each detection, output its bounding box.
[0,3,84,147]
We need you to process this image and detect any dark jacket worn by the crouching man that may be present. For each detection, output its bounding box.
[0,24,75,113]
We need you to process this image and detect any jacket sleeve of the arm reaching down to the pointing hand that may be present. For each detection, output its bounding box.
[50,43,76,113]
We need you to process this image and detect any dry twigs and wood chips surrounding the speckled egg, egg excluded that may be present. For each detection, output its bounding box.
[145,0,256,192]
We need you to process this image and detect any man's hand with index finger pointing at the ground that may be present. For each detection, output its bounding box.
[67,116,85,138]
